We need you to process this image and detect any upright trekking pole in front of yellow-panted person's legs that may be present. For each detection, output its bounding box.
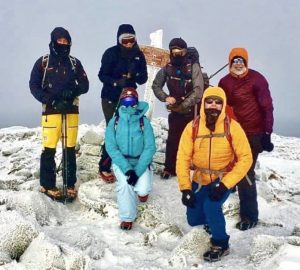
[61,113,68,199]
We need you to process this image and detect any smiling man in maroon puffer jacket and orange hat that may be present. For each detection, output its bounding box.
[219,48,274,231]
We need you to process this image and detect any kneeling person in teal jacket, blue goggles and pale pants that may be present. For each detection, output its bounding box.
[105,87,156,230]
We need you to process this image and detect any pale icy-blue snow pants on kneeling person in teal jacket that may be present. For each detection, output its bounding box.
[112,164,153,222]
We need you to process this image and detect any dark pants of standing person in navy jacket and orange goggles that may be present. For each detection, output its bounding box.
[99,99,118,171]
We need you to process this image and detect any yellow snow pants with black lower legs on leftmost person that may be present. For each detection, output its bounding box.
[40,114,79,189]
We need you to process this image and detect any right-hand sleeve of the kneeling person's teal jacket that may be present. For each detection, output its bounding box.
[134,117,156,176]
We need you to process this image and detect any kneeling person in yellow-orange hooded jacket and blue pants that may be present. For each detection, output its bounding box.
[176,87,252,262]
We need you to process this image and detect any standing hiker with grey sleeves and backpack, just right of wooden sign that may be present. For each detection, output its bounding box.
[152,38,204,179]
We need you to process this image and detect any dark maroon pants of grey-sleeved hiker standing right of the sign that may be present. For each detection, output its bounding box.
[165,112,194,175]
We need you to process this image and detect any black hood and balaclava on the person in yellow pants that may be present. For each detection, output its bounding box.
[49,27,72,58]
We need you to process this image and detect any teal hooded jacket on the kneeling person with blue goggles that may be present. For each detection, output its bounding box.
[105,101,156,176]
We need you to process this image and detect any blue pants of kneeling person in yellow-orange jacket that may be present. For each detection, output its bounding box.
[186,180,231,248]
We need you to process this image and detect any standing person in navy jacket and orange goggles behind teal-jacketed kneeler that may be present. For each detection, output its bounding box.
[98,24,148,183]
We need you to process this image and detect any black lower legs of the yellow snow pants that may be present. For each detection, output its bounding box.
[40,147,77,189]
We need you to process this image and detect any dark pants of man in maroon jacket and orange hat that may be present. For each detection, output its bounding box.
[237,134,263,222]
